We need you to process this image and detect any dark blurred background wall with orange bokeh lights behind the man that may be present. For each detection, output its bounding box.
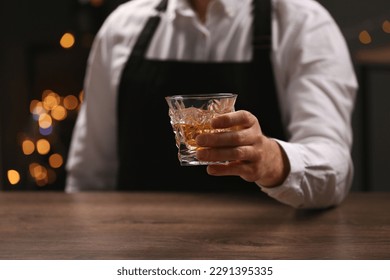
[0,0,390,191]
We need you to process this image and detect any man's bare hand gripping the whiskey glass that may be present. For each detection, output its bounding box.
[196,111,290,187]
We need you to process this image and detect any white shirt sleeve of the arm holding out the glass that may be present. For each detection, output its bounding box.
[258,1,357,208]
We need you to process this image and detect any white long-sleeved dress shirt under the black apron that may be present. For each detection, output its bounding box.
[66,0,357,208]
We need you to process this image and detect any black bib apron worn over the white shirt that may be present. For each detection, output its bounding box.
[117,0,284,191]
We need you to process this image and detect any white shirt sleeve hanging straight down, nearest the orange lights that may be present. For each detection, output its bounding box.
[65,1,154,192]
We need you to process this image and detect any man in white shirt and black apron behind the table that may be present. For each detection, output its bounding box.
[66,0,357,208]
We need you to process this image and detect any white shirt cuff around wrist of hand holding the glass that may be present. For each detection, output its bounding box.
[256,139,305,208]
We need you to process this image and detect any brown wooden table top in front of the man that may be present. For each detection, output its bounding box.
[0,192,390,260]
